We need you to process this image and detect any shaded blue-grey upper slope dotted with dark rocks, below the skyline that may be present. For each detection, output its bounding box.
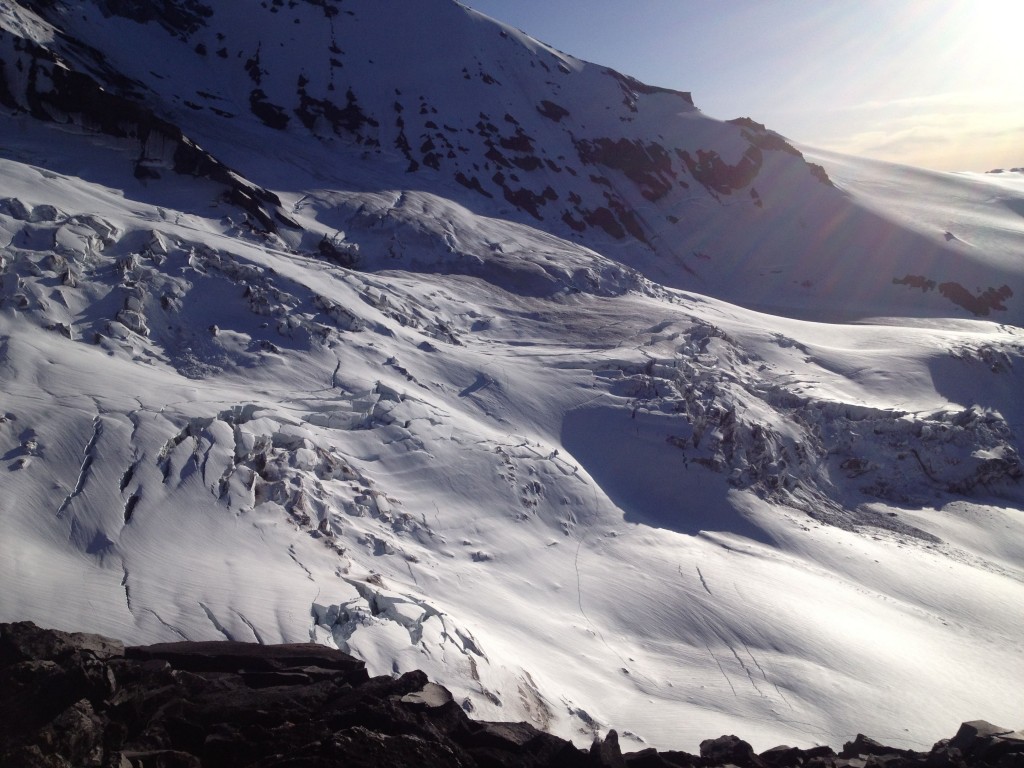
[7,0,1022,325]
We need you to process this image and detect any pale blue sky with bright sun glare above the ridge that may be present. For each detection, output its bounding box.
[463,0,1024,171]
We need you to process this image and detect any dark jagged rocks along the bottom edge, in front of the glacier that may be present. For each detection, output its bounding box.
[0,622,1024,768]
